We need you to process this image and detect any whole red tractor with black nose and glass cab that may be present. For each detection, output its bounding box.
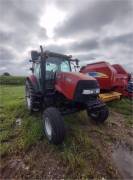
[26,46,109,144]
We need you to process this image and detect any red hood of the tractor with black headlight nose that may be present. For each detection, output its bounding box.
[55,72,99,100]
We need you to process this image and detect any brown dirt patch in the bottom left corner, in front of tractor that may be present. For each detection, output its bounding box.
[1,142,64,179]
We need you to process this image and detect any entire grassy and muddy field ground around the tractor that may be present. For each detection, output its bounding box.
[0,85,133,179]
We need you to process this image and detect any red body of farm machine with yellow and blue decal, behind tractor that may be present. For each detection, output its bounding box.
[80,61,133,98]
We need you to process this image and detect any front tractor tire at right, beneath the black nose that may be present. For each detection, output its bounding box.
[87,106,109,123]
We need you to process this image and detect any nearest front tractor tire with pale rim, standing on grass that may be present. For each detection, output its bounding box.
[42,107,66,145]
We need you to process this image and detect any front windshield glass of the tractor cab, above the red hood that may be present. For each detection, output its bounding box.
[46,57,71,72]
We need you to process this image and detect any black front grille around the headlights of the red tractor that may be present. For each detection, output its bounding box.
[74,80,99,103]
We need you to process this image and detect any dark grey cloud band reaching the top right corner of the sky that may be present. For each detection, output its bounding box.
[56,0,133,36]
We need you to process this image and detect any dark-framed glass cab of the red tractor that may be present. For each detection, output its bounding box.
[30,47,79,93]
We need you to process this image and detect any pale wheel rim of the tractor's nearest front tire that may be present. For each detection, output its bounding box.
[45,117,52,140]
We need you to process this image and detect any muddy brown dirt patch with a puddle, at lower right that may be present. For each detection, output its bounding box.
[85,111,133,179]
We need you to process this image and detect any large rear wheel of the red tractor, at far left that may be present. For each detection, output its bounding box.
[25,81,41,112]
